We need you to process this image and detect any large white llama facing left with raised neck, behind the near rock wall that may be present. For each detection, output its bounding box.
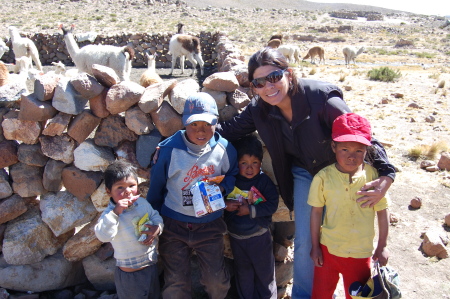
[60,25,134,81]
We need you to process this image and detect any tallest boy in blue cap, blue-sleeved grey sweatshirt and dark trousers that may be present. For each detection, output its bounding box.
[147,92,237,299]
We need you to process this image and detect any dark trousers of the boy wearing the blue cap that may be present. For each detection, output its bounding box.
[159,216,230,299]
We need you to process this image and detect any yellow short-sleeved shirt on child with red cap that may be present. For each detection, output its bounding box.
[308,164,388,258]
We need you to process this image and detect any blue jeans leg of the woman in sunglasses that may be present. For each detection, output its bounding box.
[291,166,314,299]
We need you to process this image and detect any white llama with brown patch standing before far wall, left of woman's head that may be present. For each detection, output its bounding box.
[169,34,204,76]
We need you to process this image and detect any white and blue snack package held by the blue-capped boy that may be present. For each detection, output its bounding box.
[191,181,225,217]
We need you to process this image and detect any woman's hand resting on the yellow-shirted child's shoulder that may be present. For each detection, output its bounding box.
[356,176,393,208]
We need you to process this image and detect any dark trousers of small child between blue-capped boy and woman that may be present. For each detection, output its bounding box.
[230,231,277,299]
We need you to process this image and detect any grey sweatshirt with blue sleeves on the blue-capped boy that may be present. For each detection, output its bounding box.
[147,130,238,223]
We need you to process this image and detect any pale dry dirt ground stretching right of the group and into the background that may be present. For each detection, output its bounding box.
[0,1,450,299]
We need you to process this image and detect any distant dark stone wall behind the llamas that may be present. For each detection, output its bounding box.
[2,31,220,68]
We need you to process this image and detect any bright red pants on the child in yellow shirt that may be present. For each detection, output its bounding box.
[311,244,371,299]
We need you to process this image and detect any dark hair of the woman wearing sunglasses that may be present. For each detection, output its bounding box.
[248,47,298,96]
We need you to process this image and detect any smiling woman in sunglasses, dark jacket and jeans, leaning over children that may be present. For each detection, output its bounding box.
[217,48,395,299]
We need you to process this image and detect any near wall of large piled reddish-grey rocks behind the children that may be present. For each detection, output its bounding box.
[0,34,294,298]
